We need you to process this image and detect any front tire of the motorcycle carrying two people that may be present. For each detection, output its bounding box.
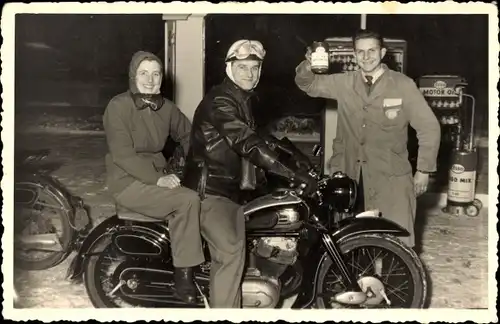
[316,234,427,309]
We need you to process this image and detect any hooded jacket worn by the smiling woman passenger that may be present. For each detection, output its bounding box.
[103,51,191,199]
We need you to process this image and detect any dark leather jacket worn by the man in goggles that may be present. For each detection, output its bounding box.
[182,78,304,203]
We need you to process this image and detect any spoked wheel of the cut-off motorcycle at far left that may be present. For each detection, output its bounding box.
[14,182,75,270]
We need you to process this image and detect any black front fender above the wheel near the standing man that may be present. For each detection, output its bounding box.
[332,216,410,242]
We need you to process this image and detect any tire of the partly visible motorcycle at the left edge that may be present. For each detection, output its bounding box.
[14,181,75,271]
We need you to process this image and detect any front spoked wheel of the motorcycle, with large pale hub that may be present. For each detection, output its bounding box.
[316,234,427,308]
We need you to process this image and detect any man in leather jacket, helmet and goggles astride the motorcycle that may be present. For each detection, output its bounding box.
[182,40,317,308]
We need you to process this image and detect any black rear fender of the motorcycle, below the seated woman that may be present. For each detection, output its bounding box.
[67,215,170,280]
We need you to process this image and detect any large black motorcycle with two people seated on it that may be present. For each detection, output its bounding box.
[67,147,427,309]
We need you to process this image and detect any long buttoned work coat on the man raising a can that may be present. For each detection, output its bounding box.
[295,61,441,246]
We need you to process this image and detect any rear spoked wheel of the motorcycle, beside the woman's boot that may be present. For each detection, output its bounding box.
[84,236,208,308]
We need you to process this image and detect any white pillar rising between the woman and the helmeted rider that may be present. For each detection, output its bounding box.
[174,15,205,120]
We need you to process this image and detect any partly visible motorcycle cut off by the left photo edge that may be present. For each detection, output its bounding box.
[14,149,92,270]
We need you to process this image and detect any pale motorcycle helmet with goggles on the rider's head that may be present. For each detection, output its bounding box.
[225,39,266,87]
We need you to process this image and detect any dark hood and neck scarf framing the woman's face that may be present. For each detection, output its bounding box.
[128,51,165,111]
